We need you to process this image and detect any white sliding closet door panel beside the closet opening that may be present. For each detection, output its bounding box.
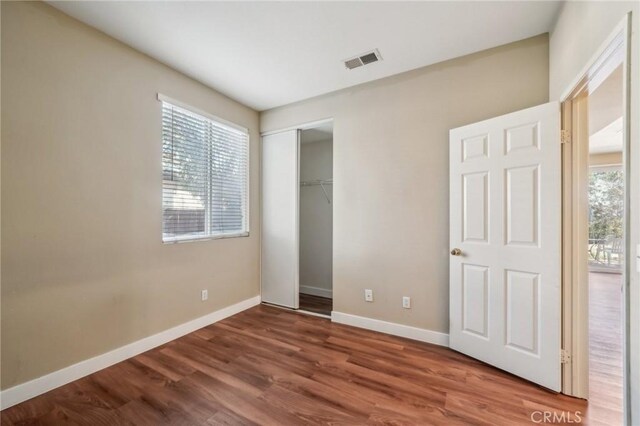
[262,130,300,309]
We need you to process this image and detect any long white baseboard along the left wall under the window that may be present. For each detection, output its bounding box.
[0,296,260,410]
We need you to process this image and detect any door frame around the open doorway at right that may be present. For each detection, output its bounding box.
[561,13,632,422]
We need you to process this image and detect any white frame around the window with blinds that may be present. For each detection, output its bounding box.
[157,93,251,244]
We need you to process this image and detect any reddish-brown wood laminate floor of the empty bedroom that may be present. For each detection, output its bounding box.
[1,306,586,426]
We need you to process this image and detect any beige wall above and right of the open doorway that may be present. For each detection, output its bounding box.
[549,1,640,424]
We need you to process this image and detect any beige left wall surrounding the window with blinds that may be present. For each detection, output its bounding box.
[2,2,259,389]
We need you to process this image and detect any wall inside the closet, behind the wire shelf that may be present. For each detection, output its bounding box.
[300,139,333,296]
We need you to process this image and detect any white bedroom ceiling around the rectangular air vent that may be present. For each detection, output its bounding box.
[50,1,560,110]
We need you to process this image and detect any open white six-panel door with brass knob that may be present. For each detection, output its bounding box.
[449,103,561,391]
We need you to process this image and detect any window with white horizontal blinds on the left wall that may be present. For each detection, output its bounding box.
[158,95,249,242]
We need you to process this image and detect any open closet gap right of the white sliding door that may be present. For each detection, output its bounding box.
[298,122,333,316]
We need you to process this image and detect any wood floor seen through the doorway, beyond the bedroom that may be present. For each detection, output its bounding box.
[589,272,623,425]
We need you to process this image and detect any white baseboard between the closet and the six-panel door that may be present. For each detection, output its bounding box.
[331,311,449,347]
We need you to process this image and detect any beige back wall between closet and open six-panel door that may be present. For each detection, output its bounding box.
[261,35,549,332]
